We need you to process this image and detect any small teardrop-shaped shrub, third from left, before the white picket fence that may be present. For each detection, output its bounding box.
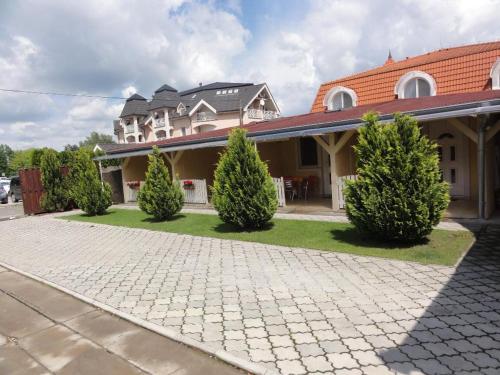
[137,146,184,220]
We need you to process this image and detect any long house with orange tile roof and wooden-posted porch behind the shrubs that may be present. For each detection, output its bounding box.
[100,42,500,217]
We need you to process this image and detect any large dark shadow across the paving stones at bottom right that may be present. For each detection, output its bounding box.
[378,224,500,374]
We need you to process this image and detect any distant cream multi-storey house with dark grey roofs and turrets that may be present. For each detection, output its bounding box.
[114,82,280,143]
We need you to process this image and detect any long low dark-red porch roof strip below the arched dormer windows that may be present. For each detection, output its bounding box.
[99,90,500,154]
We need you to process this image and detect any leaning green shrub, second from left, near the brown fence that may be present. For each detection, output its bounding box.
[68,149,111,216]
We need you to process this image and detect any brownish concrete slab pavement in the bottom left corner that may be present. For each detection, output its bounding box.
[0,267,242,375]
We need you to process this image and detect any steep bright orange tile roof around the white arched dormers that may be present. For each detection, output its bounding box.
[311,41,500,112]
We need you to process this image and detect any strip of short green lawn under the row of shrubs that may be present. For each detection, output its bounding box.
[61,209,474,265]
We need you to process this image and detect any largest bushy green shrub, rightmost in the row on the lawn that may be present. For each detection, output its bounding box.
[345,114,449,242]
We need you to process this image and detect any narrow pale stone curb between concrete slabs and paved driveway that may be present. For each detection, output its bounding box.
[0,261,277,375]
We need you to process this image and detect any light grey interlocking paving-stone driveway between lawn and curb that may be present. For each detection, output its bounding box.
[0,217,500,374]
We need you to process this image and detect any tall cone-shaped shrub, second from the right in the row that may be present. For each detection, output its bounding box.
[212,129,278,229]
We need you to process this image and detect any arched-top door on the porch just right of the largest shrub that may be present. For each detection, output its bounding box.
[433,125,469,197]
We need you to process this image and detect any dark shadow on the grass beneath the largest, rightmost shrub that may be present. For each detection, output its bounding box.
[330,228,429,249]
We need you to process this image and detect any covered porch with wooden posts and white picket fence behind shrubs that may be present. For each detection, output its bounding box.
[96,93,500,218]
